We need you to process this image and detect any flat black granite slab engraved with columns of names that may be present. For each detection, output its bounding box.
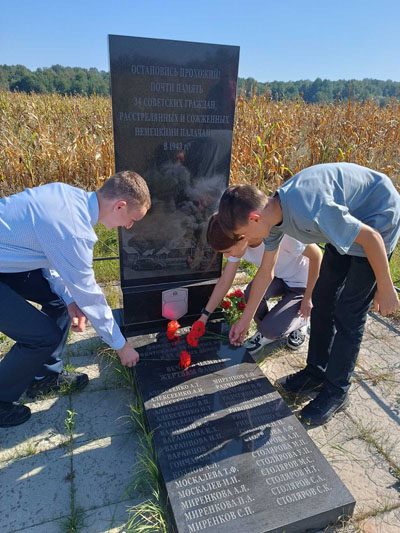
[130,322,355,533]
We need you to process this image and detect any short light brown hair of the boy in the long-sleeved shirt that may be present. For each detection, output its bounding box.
[98,170,151,209]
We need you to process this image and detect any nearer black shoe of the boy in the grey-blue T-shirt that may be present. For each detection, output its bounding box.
[300,388,350,426]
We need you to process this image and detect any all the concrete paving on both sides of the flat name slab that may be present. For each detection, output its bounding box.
[0,310,400,533]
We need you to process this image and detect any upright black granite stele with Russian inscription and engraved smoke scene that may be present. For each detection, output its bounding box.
[109,35,239,336]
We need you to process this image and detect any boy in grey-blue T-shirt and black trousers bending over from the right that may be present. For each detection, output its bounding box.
[218,163,400,425]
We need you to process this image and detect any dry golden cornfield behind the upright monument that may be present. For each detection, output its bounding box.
[0,92,400,196]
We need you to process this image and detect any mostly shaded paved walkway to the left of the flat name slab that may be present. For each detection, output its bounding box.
[0,331,147,533]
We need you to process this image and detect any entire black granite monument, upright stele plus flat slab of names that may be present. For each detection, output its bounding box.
[109,36,355,533]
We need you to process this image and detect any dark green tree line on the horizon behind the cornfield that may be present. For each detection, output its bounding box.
[0,65,400,105]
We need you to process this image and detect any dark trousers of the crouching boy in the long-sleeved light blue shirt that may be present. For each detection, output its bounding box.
[0,269,70,402]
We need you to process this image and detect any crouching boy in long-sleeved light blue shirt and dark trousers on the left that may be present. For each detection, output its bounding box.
[0,171,150,427]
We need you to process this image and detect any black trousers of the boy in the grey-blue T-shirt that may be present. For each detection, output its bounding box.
[307,244,376,393]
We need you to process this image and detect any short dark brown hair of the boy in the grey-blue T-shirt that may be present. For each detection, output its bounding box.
[218,185,267,237]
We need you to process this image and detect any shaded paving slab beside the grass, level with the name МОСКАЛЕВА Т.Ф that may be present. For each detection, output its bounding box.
[73,433,137,510]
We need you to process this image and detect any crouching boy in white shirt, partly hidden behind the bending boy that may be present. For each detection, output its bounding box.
[200,215,322,354]
